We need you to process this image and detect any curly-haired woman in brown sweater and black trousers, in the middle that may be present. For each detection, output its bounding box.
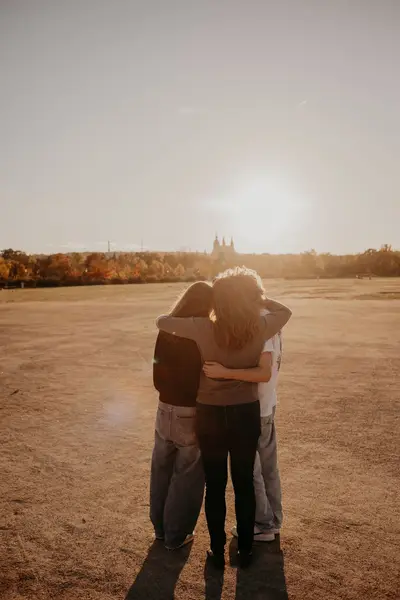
[157,267,291,568]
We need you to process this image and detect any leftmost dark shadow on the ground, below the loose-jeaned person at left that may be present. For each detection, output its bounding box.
[125,540,192,600]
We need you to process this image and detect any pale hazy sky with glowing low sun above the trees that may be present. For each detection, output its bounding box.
[0,0,400,253]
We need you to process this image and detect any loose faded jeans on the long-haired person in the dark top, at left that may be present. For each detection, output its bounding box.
[150,402,204,548]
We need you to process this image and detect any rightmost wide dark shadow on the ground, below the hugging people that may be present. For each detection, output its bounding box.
[229,535,289,600]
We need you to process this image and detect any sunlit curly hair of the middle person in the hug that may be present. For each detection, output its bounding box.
[211,267,265,350]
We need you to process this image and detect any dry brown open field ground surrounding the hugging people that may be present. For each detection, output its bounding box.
[0,280,400,600]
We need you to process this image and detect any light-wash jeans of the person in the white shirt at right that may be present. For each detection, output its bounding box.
[254,408,283,531]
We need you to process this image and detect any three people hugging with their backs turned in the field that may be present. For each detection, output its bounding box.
[150,268,291,569]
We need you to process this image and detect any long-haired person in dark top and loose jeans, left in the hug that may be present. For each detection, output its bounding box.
[150,282,212,550]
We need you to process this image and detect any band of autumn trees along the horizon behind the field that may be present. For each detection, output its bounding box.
[0,244,400,287]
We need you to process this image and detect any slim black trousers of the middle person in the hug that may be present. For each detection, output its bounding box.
[196,401,261,553]
